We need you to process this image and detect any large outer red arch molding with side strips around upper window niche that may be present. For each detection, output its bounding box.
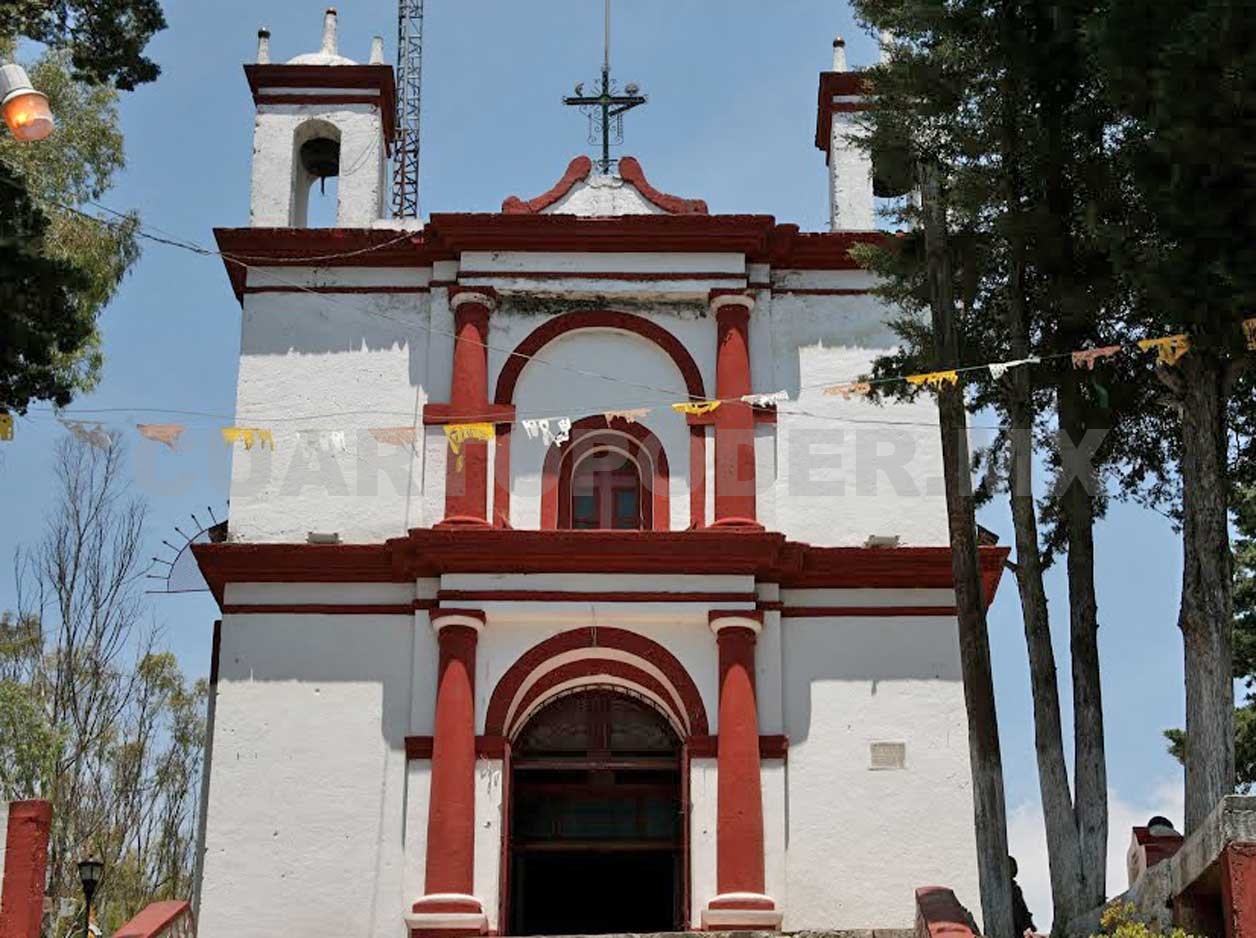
[492,309,706,530]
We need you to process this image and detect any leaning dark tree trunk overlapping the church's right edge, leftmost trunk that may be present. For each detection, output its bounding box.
[921,163,1015,938]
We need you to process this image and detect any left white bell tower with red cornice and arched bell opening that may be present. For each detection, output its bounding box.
[245,9,396,229]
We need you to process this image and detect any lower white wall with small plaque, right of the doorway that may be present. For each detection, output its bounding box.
[784,617,978,930]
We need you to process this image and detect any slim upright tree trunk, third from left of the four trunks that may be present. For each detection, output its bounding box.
[1059,369,1108,910]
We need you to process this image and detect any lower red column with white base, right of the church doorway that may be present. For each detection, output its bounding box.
[702,612,781,930]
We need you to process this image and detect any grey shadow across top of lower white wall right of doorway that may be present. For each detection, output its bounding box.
[781,617,961,745]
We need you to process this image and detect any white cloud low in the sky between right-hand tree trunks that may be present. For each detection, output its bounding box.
[1007,779,1183,932]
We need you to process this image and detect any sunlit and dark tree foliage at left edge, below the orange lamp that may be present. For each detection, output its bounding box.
[0,53,139,413]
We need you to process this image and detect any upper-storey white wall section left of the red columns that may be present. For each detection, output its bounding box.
[230,293,432,542]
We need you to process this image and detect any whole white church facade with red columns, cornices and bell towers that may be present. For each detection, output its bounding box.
[195,12,1006,938]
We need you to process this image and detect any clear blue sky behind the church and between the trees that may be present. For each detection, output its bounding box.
[0,0,1183,925]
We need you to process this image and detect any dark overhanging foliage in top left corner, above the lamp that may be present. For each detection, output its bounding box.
[0,0,166,90]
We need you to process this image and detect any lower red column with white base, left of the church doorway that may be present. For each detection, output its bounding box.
[407,610,487,934]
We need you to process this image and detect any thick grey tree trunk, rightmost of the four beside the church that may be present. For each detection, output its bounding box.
[1178,349,1235,834]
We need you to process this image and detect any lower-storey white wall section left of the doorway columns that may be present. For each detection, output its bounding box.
[198,614,411,938]
